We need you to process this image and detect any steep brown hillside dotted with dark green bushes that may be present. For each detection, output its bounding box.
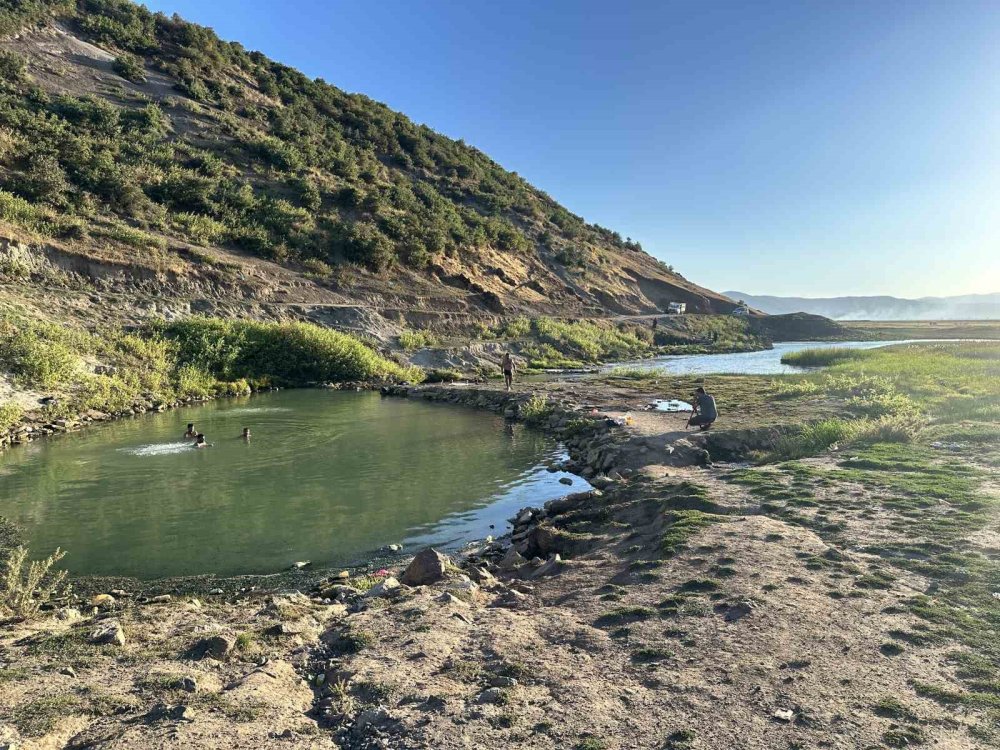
[0,0,732,334]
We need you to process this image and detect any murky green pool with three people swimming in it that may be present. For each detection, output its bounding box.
[0,390,584,578]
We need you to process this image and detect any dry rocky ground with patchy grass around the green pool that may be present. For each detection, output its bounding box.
[0,345,1000,750]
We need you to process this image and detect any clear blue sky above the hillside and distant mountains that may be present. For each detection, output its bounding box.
[137,0,1000,296]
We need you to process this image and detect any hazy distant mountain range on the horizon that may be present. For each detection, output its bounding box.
[724,292,1000,320]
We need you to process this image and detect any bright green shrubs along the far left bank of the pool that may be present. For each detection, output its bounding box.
[0,317,423,429]
